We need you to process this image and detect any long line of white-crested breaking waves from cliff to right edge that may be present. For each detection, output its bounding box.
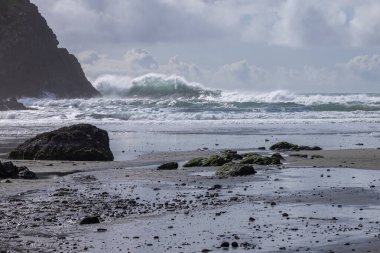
[94,73,380,106]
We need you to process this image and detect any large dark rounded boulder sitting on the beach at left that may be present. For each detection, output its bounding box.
[9,124,114,161]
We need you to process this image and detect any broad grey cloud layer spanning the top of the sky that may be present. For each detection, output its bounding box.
[32,0,380,47]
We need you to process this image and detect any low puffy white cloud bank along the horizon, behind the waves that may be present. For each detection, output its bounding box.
[79,49,380,92]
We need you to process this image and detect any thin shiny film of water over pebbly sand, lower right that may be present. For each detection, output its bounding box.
[68,168,380,252]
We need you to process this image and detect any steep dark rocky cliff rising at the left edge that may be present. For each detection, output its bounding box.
[0,0,99,98]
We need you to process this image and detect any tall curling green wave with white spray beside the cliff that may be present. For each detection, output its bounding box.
[94,74,221,98]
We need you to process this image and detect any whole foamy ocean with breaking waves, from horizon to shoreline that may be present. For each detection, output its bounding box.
[0,74,380,160]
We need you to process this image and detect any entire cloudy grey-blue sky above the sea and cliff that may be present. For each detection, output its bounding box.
[31,0,380,93]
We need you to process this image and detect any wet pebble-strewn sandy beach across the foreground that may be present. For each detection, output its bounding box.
[0,150,380,252]
